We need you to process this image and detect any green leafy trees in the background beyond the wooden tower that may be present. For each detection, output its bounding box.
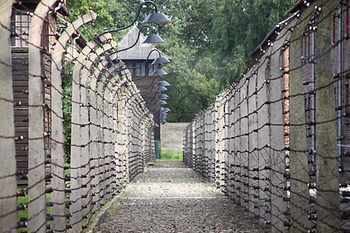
[67,0,295,122]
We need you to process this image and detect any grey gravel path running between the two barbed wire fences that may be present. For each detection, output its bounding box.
[93,162,259,233]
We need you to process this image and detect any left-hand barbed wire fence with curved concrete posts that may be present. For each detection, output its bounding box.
[0,0,154,232]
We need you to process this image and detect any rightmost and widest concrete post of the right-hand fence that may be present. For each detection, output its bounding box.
[316,2,340,233]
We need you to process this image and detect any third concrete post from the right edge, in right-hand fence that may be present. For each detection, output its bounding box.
[268,21,296,233]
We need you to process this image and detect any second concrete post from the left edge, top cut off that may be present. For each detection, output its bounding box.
[28,0,56,233]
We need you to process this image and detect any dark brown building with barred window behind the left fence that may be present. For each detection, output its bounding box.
[11,0,86,180]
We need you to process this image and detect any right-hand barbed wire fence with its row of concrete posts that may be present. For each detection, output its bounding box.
[184,1,350,233]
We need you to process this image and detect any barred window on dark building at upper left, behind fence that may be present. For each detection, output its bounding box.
[11,9,31,47]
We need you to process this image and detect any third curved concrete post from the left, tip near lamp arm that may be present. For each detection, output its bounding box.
[51,12,96,231]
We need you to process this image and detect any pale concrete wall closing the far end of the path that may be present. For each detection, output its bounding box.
[160,123,188,152]
